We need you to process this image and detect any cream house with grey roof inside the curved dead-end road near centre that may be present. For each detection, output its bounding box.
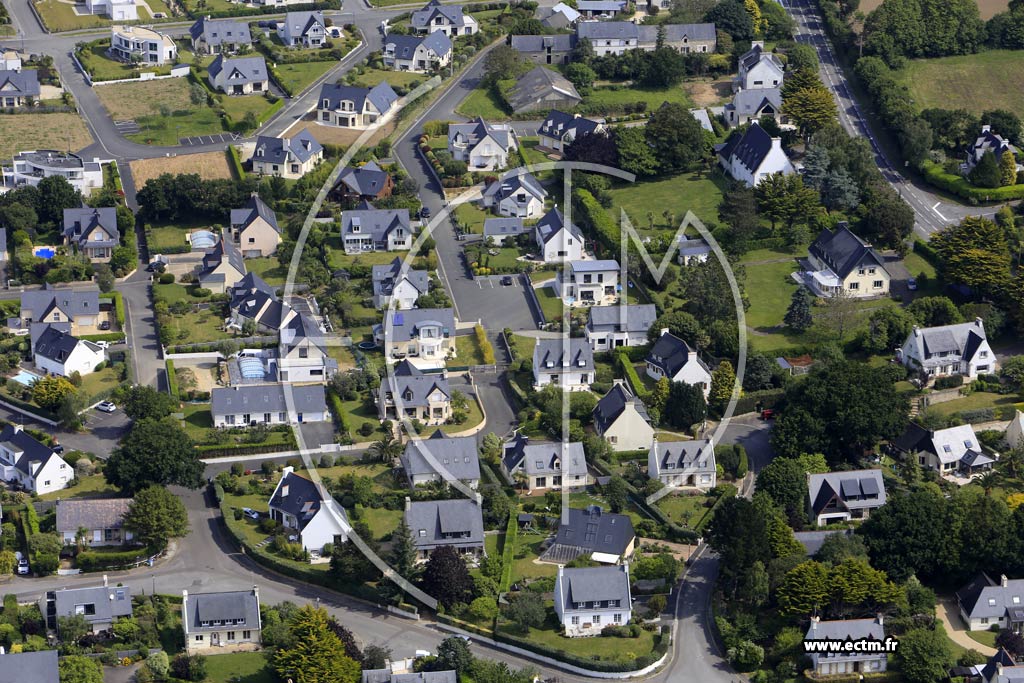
[377,360,450,423]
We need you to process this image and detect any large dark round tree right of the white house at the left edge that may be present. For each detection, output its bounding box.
[103,418,205,494]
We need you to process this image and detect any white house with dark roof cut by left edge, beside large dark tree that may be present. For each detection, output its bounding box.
[0,425,75,496]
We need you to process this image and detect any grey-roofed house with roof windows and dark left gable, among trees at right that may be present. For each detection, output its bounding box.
[807,470,886,526]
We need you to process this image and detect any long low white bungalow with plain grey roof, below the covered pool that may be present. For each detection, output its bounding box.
[210,384,331,427]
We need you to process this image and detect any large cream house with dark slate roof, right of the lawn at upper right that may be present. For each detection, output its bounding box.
[803,222,890,297]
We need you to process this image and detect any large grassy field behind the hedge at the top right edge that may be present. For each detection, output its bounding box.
[896,50,1024,114]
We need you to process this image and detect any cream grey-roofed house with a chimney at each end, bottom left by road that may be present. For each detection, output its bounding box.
[181,586,263,654]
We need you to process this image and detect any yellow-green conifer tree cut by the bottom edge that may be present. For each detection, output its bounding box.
[273,605,360,683]
